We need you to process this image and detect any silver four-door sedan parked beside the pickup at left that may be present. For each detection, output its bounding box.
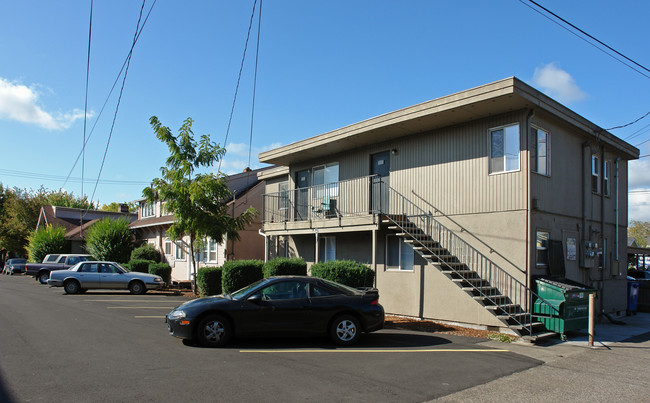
[47,261,165,294]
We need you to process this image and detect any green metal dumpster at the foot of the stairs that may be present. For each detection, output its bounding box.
[533,278,596,340]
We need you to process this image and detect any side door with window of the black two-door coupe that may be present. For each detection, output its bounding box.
[238,280,311,334]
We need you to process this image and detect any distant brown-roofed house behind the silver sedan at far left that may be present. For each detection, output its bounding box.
[36,204,138,253]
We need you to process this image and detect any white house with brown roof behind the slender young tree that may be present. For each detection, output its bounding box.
[131,168,267,281]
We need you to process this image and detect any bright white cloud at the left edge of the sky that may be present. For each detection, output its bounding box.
[0,77,92,130]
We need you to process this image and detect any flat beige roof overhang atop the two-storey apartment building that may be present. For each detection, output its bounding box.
[259,77,639,166]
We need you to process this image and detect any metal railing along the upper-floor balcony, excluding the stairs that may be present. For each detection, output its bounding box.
[262,176,379,223]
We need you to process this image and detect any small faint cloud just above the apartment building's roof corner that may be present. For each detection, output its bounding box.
[533,63,587,103]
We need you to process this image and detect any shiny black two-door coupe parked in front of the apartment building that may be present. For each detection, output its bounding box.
[166,276,384,347]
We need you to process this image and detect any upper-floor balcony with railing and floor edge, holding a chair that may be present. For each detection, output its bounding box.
[262,175,386,231]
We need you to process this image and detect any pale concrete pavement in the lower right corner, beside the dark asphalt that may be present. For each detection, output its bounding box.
[436,313,650,402]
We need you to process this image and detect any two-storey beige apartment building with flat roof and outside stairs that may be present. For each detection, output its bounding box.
[259,77,639,331]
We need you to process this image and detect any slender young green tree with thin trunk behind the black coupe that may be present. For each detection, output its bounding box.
[142,116,257,289]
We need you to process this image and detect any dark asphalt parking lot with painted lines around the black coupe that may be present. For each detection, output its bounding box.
[0,276,542,402]
